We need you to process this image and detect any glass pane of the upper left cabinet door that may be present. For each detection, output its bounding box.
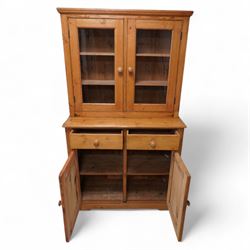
[79,29,115,103]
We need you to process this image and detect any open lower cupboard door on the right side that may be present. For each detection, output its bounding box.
[167,152,191,241]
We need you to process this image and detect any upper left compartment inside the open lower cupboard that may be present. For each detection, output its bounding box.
[78,150,122,175]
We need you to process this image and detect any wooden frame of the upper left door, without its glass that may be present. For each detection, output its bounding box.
[68,18,124,112]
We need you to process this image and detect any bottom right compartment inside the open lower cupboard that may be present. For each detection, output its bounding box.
[127,176,168,201]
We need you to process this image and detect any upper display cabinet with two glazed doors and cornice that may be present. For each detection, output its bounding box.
[59,9,192,117]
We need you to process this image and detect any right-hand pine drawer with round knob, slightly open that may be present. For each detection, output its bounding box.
[127,131,180,150]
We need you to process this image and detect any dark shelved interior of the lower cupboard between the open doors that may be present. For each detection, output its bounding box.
[78,147,171,201]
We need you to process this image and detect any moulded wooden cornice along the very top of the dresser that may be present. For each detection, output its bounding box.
[57,8,193,17]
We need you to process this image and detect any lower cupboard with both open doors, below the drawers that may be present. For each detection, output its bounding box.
[59,149,191,241]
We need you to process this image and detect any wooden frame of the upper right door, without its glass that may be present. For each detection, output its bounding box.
[127,18,183,113]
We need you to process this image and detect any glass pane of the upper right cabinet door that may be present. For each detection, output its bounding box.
[134,30,172,104]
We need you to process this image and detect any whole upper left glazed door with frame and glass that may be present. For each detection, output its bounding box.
[69,19,123,112]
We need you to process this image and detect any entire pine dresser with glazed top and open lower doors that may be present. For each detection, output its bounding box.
[58,8,192,241]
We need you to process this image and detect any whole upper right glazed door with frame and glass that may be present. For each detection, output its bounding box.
[127,19,182,112]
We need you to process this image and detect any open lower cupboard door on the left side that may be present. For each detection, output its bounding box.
[59,151,81,242]
